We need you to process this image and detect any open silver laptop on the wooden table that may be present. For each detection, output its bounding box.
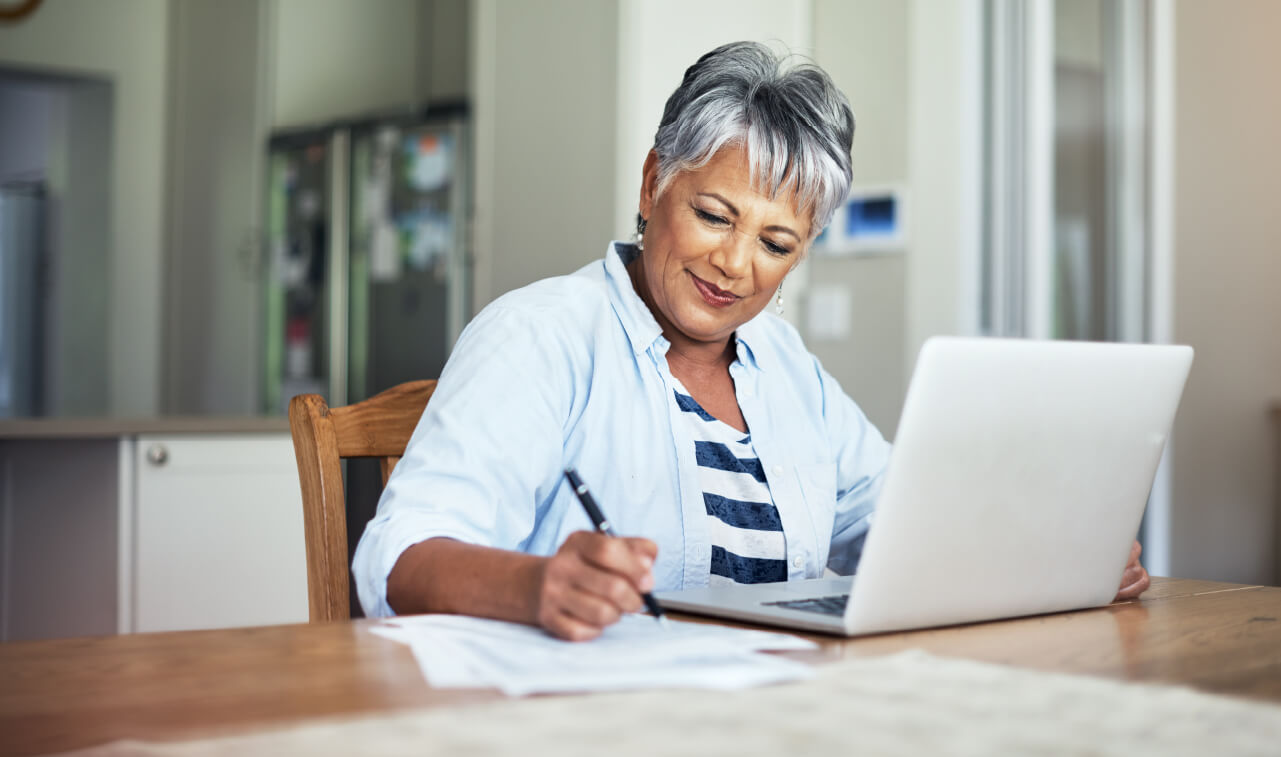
[656,337,1193,637]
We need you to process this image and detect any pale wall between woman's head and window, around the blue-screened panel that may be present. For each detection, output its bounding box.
[808,0,983,438]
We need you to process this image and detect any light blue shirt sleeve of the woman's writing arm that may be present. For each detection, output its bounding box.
[352,302,570,616]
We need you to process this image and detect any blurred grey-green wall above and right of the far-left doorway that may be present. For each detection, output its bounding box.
[0,0,169,414]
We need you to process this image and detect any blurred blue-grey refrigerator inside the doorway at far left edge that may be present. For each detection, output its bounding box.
[0,182,49,418]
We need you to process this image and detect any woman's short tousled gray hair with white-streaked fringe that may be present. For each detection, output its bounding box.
[653,42,854,238]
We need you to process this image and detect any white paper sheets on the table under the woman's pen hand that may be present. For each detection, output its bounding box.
[373,615,815,697]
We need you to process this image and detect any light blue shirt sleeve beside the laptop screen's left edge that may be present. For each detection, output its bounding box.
[815,361,890,575]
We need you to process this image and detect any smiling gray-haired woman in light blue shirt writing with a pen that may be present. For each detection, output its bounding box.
[354,42,1146,639]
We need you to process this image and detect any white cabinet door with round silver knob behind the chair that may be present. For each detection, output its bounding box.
[132,434,307,631]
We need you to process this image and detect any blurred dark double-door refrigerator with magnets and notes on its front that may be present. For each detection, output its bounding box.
[264,106,471,414]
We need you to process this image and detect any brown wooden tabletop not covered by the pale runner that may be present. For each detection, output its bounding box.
[0,578,1281,754]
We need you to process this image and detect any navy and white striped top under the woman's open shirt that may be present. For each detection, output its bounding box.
[673,382,788,587]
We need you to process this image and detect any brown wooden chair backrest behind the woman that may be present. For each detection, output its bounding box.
[290,380,436,623]
